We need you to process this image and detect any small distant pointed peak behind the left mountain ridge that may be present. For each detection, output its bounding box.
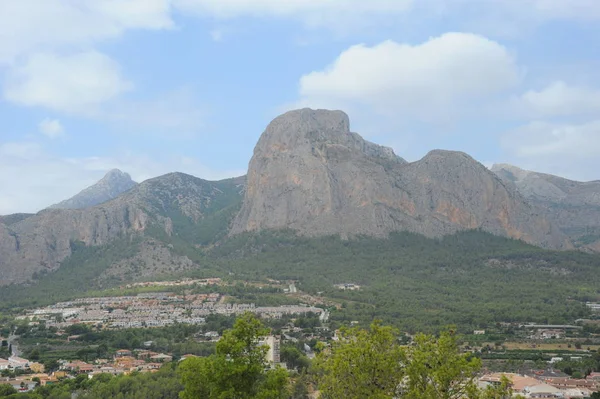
[50,169,137,209]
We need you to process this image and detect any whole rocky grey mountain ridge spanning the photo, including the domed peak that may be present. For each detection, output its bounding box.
[0,109,600,285]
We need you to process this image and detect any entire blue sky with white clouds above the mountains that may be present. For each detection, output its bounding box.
[0,0,600,214]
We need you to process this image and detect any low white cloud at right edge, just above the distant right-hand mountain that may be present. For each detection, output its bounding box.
[501,120,600,180]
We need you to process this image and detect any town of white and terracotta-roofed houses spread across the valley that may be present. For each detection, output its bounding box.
[0,279,600,399]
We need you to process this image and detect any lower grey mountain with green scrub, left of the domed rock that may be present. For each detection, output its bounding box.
[0,173,244,285]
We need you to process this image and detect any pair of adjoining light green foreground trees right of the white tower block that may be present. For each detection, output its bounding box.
[315,323,512,399]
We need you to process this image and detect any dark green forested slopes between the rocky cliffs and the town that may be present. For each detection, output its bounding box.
[0,231,600,332]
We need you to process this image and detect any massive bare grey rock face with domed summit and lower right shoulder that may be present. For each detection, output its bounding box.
[231,109,570,248]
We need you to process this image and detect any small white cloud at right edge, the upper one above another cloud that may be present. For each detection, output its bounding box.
[516,81,600,118]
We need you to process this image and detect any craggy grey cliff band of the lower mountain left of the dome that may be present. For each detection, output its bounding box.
[0,173,244,285]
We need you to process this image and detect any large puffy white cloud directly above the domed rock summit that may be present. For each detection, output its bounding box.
[300,33,520,119]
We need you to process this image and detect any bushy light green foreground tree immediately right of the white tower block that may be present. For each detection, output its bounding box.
[316,321,405,399]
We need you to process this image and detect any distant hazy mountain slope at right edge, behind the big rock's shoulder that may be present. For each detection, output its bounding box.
[492,164,600,252]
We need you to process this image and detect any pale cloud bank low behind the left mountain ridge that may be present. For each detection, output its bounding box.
[0,141,245,215]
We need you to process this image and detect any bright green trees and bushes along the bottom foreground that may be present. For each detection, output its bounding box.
[0,313,600,399]
